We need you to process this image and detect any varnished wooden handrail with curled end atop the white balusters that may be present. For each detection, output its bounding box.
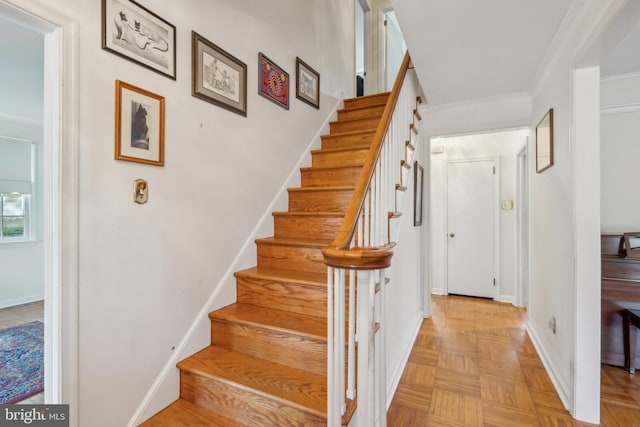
[322,51,411,270]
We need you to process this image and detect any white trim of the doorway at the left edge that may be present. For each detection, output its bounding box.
[0,0,79,426]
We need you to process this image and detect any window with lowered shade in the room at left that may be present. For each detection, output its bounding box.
[0,136,35,244]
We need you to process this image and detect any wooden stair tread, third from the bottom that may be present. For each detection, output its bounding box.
[209,303,327,340]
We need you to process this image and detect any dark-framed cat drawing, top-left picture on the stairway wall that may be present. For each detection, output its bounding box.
[102,0,176,80]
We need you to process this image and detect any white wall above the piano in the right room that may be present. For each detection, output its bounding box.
[600,74,640,233]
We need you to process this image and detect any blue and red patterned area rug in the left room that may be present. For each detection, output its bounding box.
[0,320,44,404]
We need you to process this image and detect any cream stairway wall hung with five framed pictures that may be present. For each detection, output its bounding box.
[2,0,354,427]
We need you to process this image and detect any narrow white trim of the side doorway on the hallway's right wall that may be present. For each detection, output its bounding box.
[513,137,531,307]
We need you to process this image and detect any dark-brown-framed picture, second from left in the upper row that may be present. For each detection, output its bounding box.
[191,31,247,117]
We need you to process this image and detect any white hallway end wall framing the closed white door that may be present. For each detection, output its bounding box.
[429,129,529,302]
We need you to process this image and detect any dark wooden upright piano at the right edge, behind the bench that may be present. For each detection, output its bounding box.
[601,233,640,367]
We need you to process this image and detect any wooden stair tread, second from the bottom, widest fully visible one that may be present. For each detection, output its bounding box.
[178,346,327,417]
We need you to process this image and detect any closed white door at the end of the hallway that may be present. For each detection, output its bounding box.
[447,160,497,298]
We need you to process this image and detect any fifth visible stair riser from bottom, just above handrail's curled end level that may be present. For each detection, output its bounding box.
[273,215,343,240]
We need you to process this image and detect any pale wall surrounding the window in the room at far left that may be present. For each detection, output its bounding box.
[0,17,44,308]
